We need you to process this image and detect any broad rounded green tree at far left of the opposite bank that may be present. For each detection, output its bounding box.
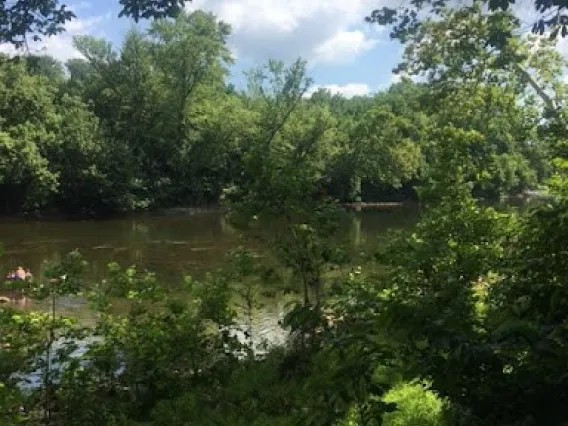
[0,52,138,213]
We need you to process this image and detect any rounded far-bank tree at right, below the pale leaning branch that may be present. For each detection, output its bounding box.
[423,85,549,199]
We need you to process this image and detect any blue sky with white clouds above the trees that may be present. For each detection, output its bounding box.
[0,0,568,97]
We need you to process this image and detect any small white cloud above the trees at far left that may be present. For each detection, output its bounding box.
[0,15,110,62]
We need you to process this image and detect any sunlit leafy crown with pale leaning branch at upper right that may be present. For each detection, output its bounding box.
[397,2,566,111]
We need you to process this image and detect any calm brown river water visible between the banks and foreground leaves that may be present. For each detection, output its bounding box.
[0,205,418,350]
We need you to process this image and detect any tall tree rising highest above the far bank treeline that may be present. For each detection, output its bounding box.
[148,11,233,205]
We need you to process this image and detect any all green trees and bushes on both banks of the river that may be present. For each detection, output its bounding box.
[0,0,568,426]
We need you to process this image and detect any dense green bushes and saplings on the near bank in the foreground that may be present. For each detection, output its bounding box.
[0,168,568,425]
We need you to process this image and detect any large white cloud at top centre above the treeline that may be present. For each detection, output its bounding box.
[187,0,387,64]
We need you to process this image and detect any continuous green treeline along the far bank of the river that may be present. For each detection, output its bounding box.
[0,12,548,214]
